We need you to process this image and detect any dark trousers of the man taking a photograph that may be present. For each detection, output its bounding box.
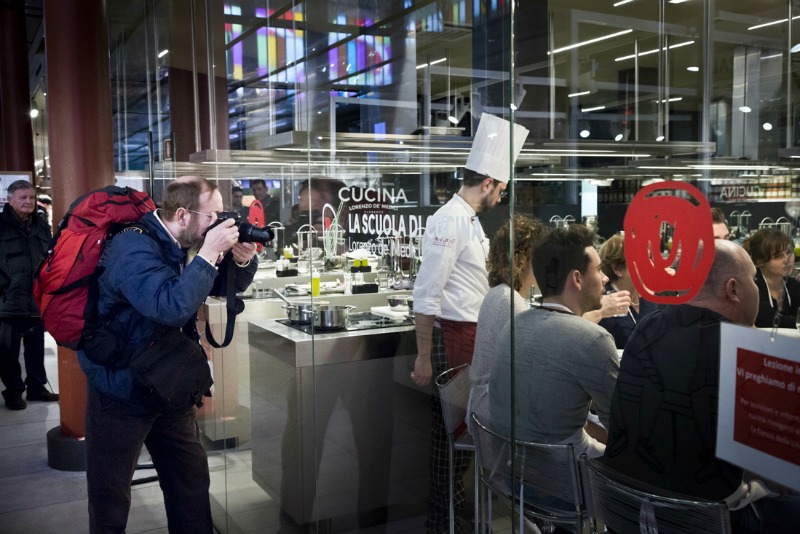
[86,385,213,534]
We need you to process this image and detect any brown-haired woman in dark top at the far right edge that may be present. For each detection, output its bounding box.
[743,228,800,328]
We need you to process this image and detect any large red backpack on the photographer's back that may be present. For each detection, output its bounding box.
[33,186,156,350]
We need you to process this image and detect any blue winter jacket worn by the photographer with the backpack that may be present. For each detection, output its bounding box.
[78,213,258,404]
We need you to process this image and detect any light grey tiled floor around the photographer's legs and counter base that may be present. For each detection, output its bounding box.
[0,338,511,534]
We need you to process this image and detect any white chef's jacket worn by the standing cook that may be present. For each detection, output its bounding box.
[414,194,489,322]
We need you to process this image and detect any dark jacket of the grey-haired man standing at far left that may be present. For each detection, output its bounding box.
[0,204,50,317]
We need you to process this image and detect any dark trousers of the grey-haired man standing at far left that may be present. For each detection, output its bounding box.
[0,317,47,398]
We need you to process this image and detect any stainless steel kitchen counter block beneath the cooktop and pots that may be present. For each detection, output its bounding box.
[248,320,430,526]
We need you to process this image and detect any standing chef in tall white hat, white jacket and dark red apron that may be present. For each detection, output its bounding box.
[411,113,528,534]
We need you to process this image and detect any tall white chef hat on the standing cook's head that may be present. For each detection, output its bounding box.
[466,113,528,182]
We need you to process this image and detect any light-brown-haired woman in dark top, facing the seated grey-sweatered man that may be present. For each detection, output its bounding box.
[600,235,657,349]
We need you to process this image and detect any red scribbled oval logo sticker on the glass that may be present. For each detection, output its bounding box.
[624,182,714,304]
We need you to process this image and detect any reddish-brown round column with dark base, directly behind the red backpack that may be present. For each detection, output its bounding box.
[43,0,114,470]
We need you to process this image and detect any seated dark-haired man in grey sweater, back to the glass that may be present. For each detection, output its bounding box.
[487,225,619,457]
